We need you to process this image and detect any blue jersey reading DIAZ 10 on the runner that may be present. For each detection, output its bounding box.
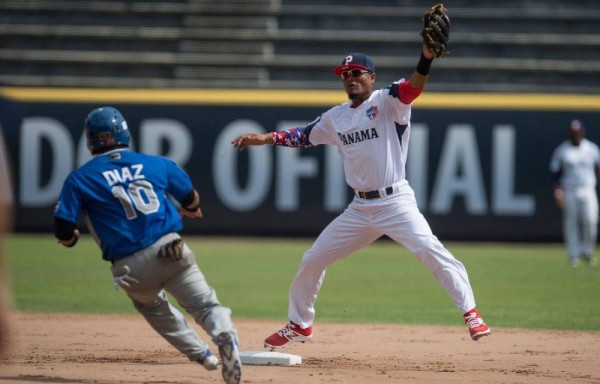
[54,149,193,262]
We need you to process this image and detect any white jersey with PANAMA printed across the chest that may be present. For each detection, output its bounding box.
[309,79,411,191]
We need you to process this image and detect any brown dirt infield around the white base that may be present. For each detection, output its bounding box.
[0,313,600,384]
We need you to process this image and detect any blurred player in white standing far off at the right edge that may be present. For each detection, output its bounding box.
[550,120,600,267]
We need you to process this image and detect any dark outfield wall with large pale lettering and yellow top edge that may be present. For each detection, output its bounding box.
[0,88,600,241]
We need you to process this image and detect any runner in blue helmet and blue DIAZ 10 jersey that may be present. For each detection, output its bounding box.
[54,107,241,384]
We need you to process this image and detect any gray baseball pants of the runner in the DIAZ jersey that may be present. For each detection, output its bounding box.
[111,233,237,361]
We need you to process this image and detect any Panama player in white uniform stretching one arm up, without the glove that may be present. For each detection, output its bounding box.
[232,45,490,349]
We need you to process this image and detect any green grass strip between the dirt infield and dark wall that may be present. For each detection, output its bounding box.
[6,235,600,330]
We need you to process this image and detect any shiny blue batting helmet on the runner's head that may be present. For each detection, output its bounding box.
[84,107,130,153]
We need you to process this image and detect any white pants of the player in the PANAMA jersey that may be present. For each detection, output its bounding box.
[288,181,475,328]
